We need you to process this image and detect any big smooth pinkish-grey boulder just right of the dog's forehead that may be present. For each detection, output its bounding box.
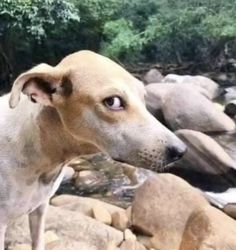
[145,83,235,132]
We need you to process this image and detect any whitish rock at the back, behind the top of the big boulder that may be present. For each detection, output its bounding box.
[162,74,221,100]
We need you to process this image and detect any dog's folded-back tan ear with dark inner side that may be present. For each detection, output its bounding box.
[9,63,72,108]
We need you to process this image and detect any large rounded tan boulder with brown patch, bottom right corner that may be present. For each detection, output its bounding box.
[132,174,236,250]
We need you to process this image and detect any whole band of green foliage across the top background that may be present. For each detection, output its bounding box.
[0,0,236,92]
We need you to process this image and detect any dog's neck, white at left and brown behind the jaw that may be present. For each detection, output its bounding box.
[0,95,97,175]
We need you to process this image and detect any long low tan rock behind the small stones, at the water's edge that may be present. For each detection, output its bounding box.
[51,194,125,217]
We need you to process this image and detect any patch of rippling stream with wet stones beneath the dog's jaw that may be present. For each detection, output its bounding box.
[57,154,153,207]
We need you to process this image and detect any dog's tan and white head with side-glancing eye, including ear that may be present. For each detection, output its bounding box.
[10,51,186,170]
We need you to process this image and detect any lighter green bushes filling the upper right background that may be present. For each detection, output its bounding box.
[100,0,236,62]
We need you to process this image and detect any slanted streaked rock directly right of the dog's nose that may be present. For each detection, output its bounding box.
[176,129,236,174]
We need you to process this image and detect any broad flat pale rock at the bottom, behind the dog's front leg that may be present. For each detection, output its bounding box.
[6,206,123,250]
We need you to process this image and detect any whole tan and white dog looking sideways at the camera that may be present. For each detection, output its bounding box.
[0,51,185,250]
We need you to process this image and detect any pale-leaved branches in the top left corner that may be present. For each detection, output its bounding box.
[0,0,79,40]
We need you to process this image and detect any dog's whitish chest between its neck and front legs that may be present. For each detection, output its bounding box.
[0,164,64,222]
